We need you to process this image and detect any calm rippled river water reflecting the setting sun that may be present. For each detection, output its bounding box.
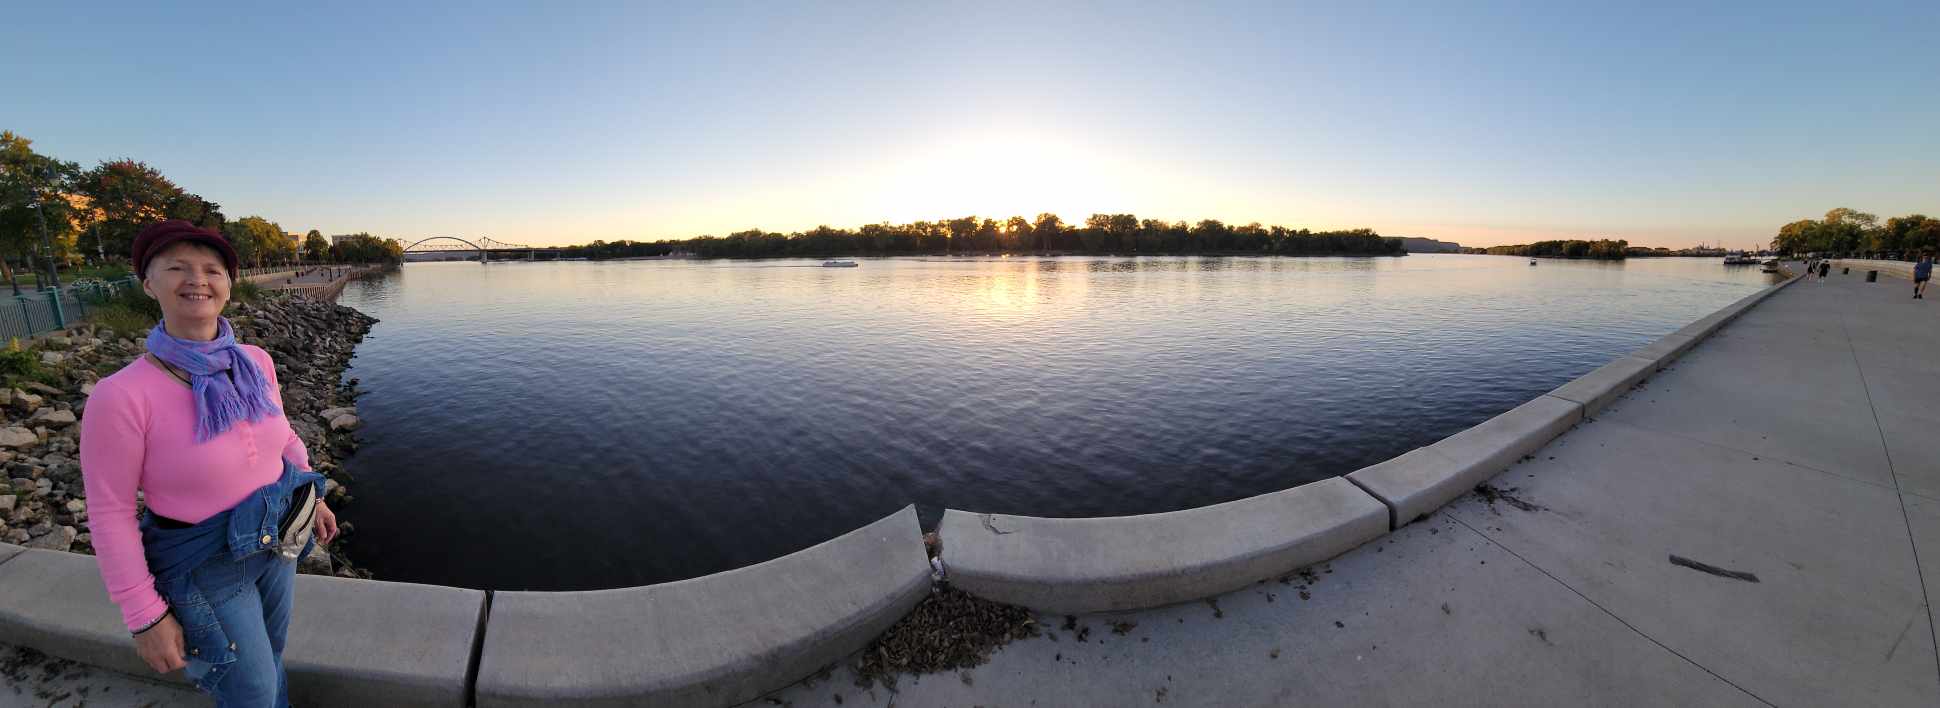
[340,254,1773,590]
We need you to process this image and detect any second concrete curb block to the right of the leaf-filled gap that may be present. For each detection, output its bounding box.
[1346,394,1583,528]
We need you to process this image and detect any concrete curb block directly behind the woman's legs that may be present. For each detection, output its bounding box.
[0,551,485,706]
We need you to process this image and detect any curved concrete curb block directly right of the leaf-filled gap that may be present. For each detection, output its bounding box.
[937,477,1387,613]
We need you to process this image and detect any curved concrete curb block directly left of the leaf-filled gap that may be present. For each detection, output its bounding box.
[477,506,929,708]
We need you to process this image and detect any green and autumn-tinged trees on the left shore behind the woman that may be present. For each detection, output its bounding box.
[0,132,404,289]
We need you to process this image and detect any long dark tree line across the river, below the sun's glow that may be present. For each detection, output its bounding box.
[565,213,1403,258]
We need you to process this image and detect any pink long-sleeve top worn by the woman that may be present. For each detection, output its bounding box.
[81,345,310,630]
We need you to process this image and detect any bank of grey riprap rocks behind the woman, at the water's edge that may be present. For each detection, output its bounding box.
[0,297,376,578]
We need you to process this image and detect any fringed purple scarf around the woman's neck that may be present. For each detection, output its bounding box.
[147,318,283,442]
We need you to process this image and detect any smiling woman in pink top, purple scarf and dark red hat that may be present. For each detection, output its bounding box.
[81,219,338,708]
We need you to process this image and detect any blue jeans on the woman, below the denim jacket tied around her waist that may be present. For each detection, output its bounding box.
[184,553,297,708]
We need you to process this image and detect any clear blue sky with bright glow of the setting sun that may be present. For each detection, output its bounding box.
[0,0,1940,246]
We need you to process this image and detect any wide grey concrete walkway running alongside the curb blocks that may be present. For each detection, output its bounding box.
[0,267,1940,706]
